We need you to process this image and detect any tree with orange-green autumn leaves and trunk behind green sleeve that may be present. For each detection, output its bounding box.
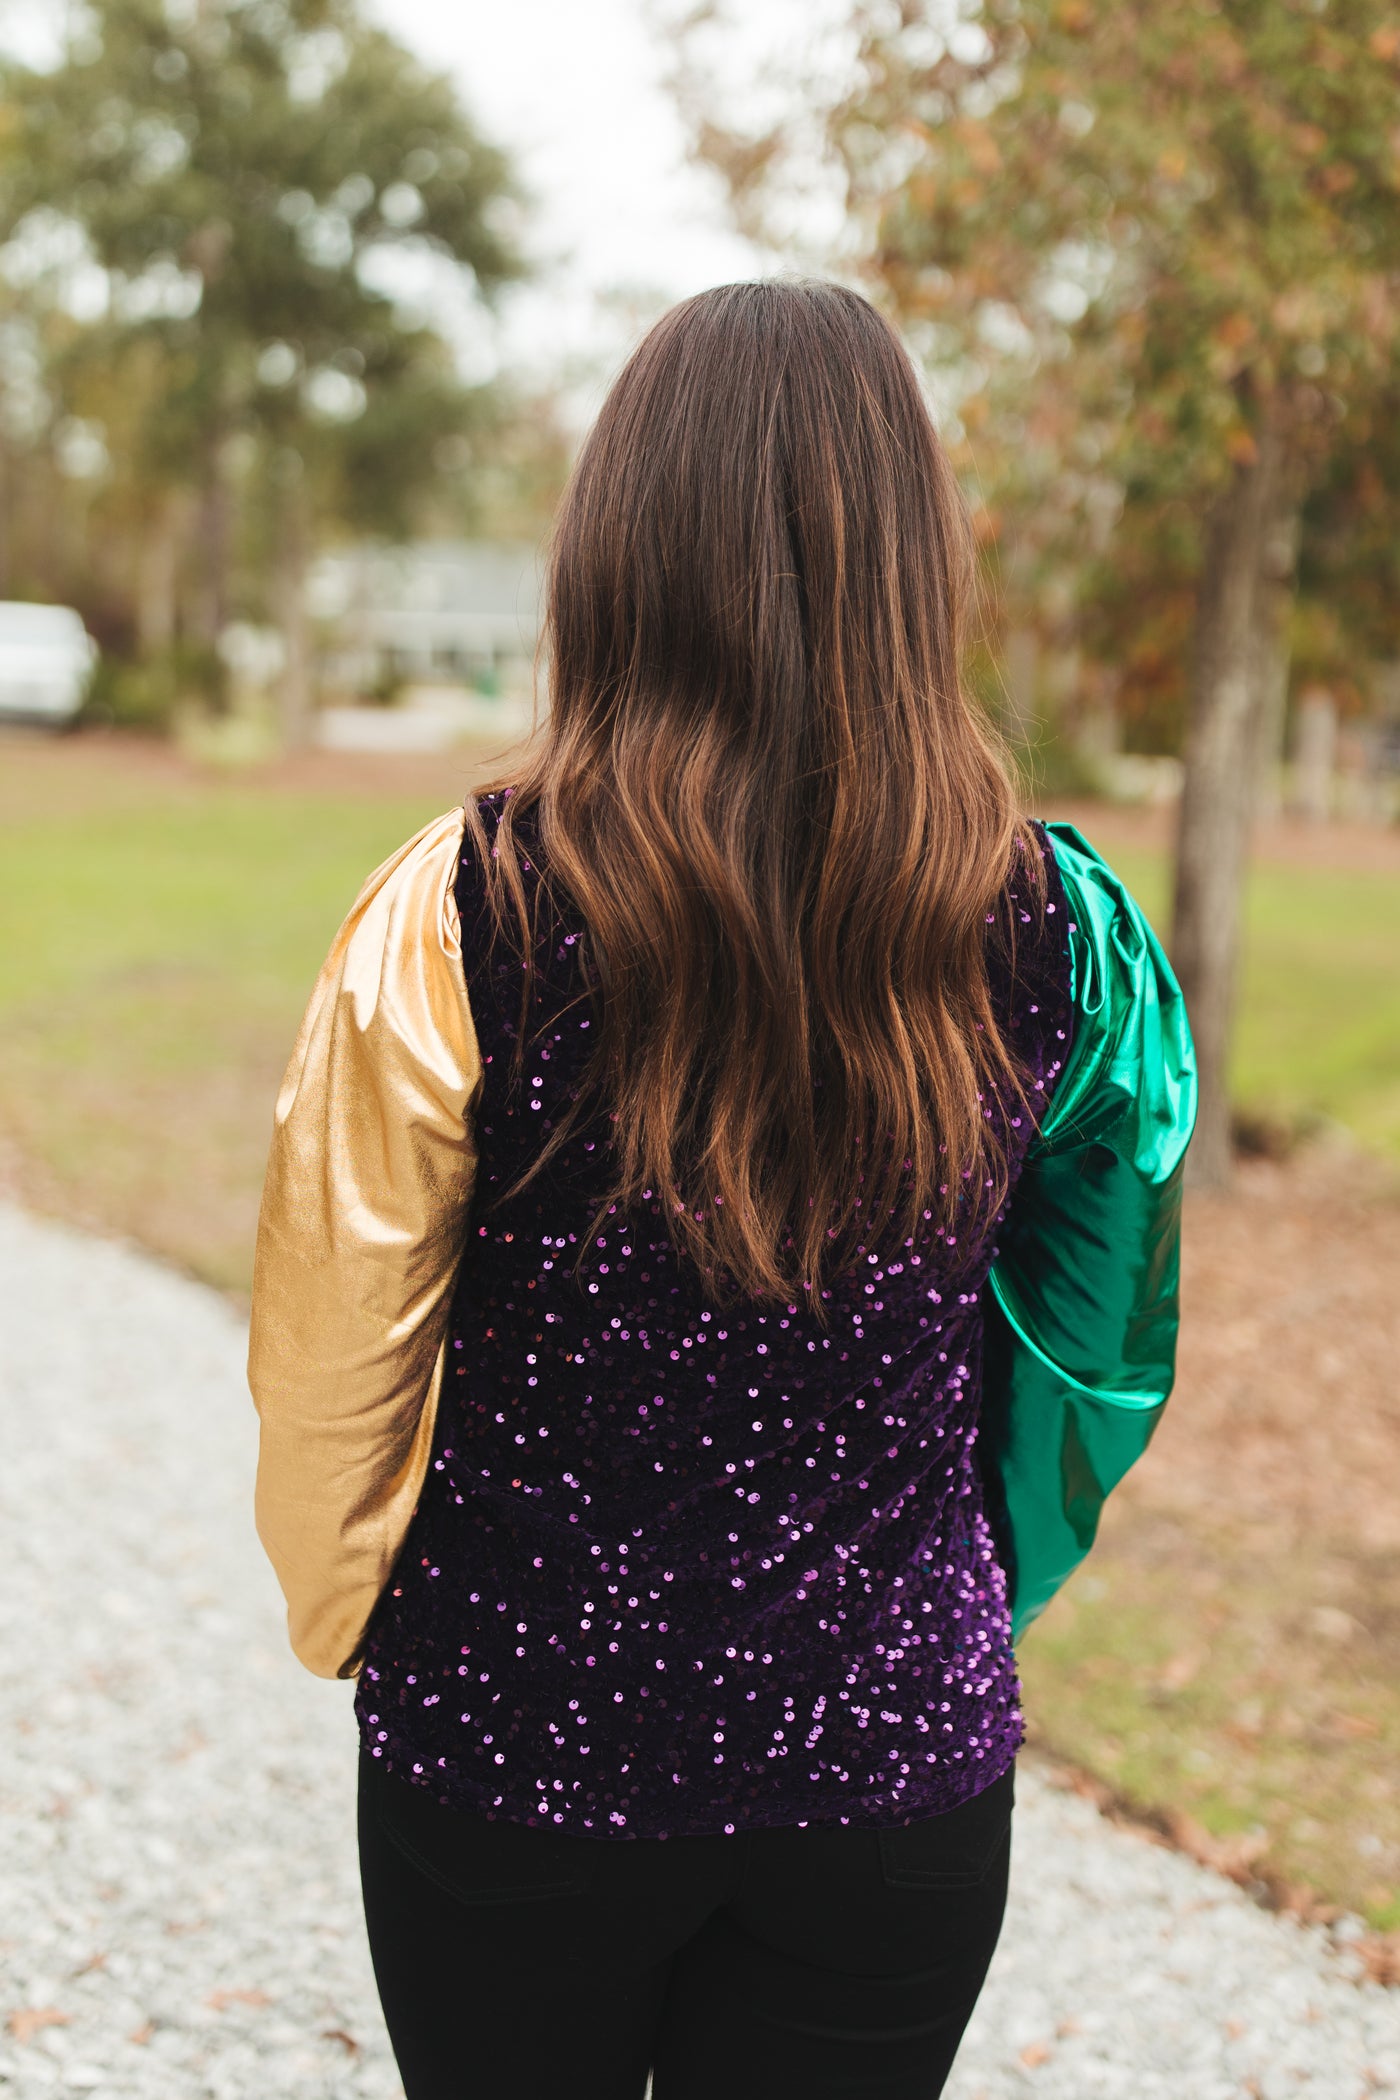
[680,0,1400,1184]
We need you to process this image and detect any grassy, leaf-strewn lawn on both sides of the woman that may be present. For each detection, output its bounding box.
[0,737,1400,1928]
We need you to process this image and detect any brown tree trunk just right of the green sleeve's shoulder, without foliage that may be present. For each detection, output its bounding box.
[1171,424,1291,1189]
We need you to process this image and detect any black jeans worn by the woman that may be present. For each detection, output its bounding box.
[359,1756,1014,2100]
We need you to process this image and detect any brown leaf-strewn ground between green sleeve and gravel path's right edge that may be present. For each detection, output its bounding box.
[1022,1145,1400,1980]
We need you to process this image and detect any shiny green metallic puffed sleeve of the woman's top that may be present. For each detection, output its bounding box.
[984,823,1196,1638]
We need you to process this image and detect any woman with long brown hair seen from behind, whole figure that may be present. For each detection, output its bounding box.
[250,284,1192,2100]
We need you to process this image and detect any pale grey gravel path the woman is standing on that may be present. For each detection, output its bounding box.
[0,1210,1400,2100]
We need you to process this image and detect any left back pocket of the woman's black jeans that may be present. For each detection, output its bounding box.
[369,1775,598,1905]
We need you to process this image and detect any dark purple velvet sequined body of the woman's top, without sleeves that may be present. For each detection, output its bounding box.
[357,798,1073,1838]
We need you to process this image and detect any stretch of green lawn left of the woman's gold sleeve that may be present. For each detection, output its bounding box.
[0,741,476,1292]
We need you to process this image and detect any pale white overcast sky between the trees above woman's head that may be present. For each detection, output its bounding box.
[0,0,848,418]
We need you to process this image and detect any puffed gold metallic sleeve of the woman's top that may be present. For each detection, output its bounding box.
[248,811,481,1678]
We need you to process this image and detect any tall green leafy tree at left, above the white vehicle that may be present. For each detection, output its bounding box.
[0,0,521,733]
